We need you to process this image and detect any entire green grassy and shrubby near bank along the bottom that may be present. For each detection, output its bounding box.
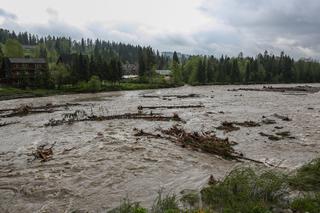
[110,159,320,213]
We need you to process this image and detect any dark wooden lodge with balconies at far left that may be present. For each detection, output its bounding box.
[0,58,48,86]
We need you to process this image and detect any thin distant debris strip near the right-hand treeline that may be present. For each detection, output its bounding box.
[228,86,320,93]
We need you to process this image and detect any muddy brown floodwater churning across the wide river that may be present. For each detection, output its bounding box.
[0,85,320,212]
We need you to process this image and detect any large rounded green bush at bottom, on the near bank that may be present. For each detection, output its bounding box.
[201,168,287,213]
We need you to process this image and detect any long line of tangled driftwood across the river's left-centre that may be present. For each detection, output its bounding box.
[45,110,184,126]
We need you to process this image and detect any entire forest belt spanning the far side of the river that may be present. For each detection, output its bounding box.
[0,29,320,89]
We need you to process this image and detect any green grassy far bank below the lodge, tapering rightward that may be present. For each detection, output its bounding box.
[0,82,181,101]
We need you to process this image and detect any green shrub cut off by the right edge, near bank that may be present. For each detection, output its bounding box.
[289,158,320,192]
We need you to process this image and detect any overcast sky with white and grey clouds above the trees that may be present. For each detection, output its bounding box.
[0,0,320,59]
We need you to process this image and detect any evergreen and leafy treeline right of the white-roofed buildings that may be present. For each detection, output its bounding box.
[180,51,320,84]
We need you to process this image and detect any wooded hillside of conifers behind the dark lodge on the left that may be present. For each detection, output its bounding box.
[0,29,169,86]
